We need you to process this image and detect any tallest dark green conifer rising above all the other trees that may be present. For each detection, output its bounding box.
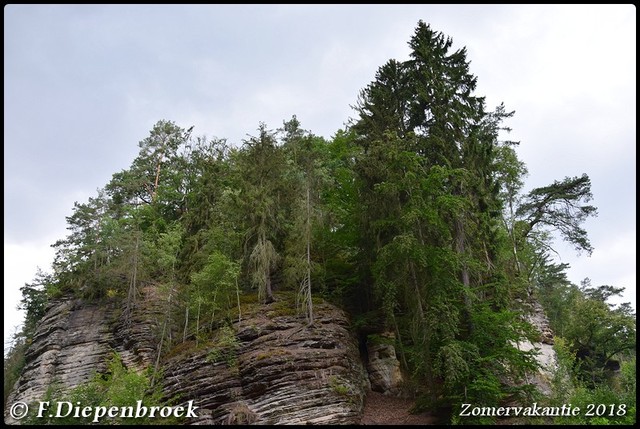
[351,21,544,412]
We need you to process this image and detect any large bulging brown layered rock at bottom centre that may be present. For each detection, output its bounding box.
[164,303,368,424]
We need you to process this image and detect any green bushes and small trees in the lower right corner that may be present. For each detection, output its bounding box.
[549,281,636,425]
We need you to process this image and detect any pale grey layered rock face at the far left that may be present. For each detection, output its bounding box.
[5,287,162,424]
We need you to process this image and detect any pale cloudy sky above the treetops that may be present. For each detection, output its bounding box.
[4,4,636,345]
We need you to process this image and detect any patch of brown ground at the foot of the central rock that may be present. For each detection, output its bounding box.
[360,391,436,425]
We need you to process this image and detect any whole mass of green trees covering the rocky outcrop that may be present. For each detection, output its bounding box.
[11,21,635,423]
